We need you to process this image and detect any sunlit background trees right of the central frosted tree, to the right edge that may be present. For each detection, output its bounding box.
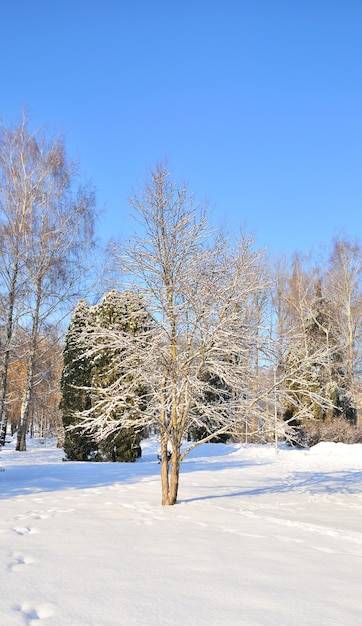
[271,237,362,444]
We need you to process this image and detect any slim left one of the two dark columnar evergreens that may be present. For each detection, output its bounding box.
[59,300,98,461]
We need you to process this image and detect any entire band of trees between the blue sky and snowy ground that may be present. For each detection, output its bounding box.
[0,117,362,482]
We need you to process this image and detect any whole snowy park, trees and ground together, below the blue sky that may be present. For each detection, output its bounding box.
[0,118,362,626]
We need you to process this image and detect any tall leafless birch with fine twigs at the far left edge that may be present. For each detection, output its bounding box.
[0,115,94,450]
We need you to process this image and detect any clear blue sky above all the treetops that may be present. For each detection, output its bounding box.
[0,0,362,254]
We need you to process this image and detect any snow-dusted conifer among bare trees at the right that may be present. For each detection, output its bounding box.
[281,258,349,440]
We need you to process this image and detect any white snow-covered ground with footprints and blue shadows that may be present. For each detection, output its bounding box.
[0,434,362,626]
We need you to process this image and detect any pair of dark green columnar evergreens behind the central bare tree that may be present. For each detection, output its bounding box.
[60,290,150,461]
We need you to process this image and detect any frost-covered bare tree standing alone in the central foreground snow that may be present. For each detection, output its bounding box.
[72,164,272,505]
